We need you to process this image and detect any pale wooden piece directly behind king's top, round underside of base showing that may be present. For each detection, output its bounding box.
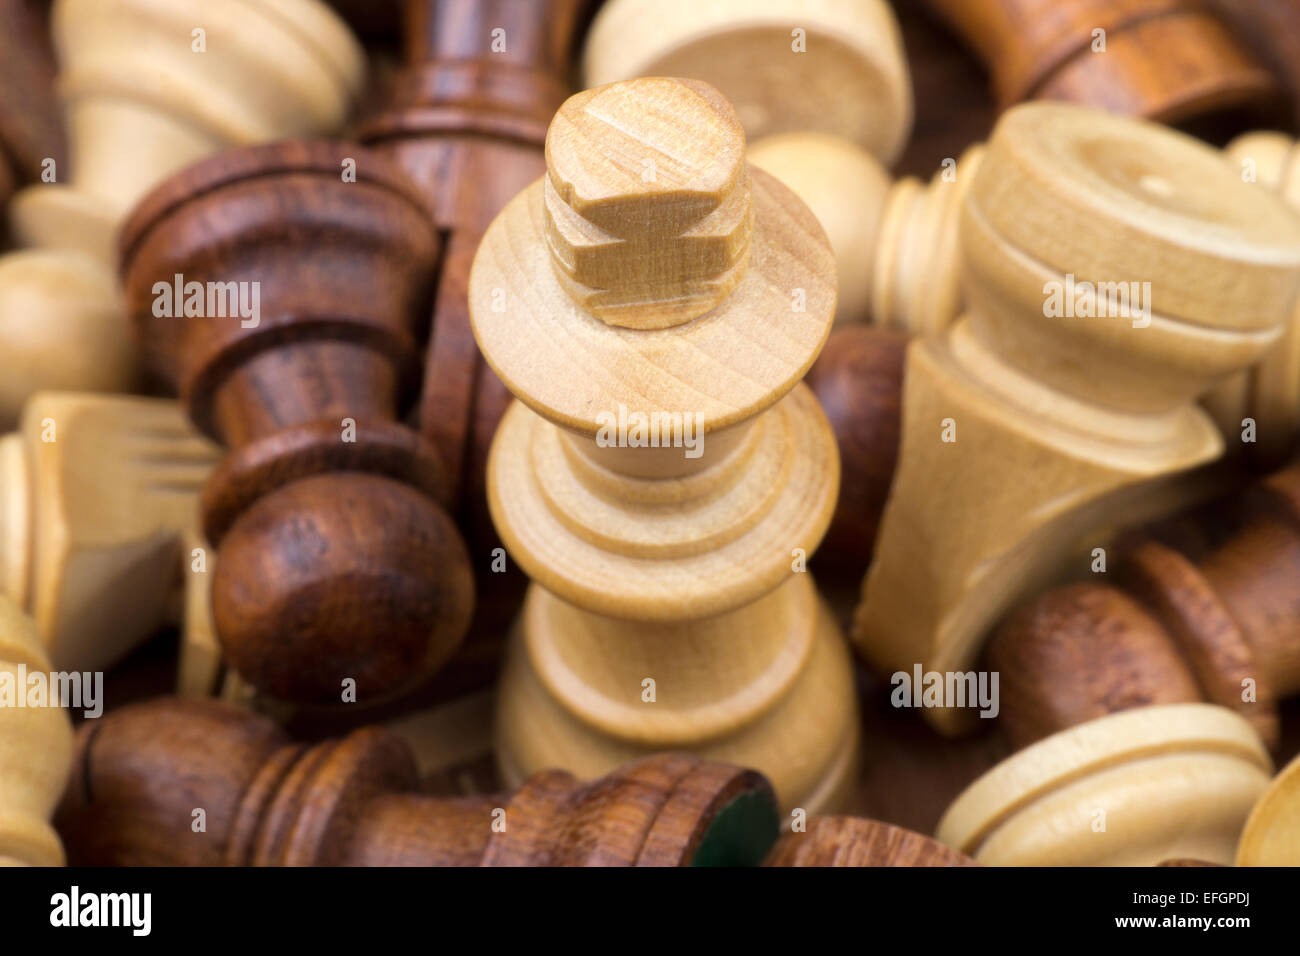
[582,0,913,166]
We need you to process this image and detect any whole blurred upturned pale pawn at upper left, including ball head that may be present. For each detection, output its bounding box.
[0,0,364,428]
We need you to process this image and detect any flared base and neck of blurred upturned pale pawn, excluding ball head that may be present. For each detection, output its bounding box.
[10,0,364,261]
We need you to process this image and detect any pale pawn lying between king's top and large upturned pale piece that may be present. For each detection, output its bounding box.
[749,133,984,334]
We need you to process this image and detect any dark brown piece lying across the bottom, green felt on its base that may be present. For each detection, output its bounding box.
[57,698,777,866]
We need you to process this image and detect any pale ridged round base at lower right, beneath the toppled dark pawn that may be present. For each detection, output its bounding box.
[935,704,1273,866]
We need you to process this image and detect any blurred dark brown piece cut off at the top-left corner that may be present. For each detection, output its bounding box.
[0,0,66,206]
